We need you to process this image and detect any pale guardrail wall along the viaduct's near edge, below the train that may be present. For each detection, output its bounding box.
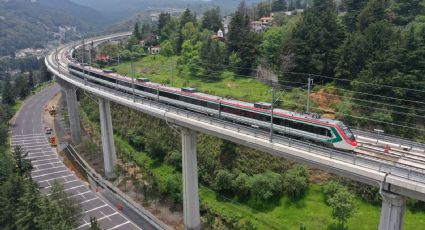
[47,40,425,190]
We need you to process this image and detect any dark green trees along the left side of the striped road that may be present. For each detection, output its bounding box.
[0,60,80,230]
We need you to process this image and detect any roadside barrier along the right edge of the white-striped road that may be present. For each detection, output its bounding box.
[64,145,171,230]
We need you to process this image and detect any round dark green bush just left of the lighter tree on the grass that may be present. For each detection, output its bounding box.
[283,165,308,199]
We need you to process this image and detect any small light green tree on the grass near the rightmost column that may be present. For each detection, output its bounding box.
[328,186,356,226]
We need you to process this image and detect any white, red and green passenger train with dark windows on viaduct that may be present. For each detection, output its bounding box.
[68,60,357,151]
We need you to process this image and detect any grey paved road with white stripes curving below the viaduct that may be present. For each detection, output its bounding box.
[12,85,140,229]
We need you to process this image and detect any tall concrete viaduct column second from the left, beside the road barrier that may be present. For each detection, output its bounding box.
[99,98,117,179]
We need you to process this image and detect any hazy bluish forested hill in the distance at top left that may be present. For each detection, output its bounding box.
[0,0,103,56]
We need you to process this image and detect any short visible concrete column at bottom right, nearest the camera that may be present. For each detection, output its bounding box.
[379,192,406,230]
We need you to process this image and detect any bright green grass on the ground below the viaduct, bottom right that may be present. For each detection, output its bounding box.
[199,185,425,230]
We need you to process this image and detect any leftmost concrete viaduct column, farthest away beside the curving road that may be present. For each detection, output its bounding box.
[61,84,81,145]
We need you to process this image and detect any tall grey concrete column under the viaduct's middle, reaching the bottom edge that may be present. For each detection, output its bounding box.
[181,128,201,230]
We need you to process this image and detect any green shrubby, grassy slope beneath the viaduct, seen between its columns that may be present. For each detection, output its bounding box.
[81,97,425,229]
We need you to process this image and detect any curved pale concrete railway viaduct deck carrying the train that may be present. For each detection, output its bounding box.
[46,33,425,200]
